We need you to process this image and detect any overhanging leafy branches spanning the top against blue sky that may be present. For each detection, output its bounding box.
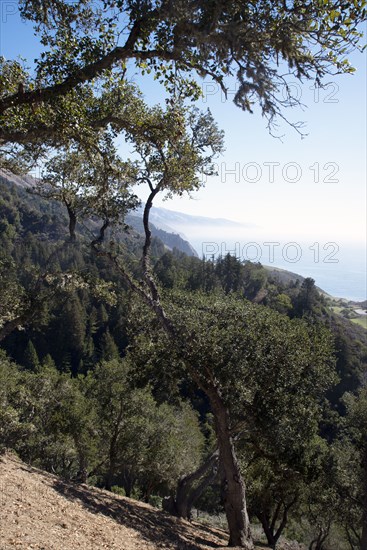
[0,0,366,163]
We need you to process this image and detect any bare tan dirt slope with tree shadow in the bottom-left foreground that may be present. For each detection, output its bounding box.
[0,454,302,550]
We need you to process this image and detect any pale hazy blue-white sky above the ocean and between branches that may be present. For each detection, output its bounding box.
[0,5,367,249]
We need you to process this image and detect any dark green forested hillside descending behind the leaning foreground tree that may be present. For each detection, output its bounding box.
[0,170,367,548]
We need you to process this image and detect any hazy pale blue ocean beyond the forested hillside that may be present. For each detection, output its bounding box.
[148,208,367,302]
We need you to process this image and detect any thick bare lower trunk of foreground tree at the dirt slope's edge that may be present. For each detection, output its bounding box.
[207,385,254,550]
